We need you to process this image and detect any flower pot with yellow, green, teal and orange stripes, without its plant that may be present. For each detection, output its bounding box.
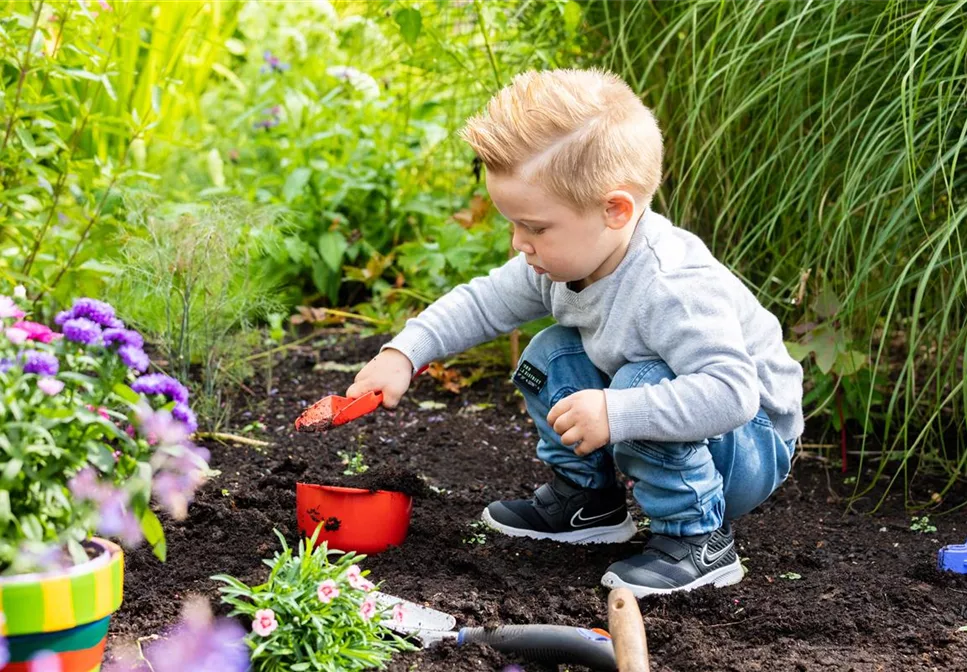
[0,538,124,672]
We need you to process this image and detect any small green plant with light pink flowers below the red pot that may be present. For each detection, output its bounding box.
[212,529,414,672]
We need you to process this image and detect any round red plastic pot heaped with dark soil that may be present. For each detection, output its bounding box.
[295,483,413,555]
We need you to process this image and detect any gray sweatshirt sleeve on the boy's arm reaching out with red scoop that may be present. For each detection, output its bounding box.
[381,256,550,370]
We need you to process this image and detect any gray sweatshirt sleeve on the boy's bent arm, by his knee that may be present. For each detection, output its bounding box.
[605,272,759,443]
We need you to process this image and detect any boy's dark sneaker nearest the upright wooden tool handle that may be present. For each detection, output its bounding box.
[601,523,744,597]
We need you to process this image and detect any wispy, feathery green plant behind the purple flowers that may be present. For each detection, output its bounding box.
[111,197,280,425]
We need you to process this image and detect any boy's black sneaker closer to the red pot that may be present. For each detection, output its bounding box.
[481,474,637,544]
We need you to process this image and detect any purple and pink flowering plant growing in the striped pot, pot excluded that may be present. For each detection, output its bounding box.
[0,287,208,573]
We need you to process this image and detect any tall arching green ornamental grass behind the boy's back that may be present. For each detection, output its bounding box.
[586,0,967,498]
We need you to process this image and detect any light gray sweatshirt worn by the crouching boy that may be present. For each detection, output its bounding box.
[383,211,803,443]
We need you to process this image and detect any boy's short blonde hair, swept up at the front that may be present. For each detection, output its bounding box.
[460,69,662,210]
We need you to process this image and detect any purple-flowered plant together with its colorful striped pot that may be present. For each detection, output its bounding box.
[0,287,208,672]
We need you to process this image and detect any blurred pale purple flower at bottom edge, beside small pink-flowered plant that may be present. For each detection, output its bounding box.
[145,602,250,672]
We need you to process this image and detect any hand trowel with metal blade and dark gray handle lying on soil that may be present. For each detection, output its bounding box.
[376,593,618,671]
